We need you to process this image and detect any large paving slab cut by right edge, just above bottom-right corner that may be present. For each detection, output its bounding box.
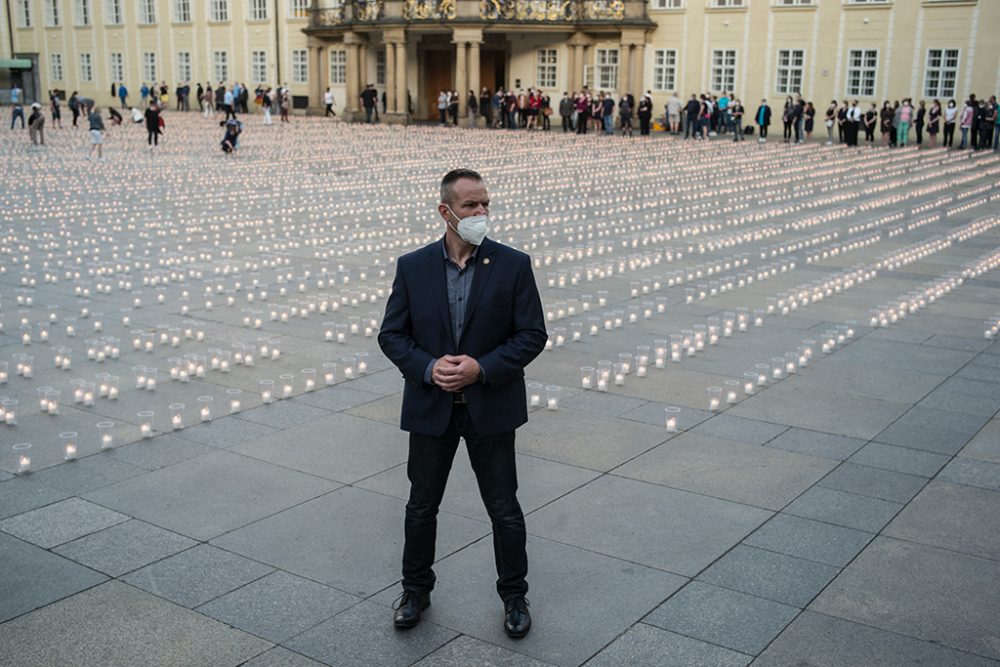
[810,537,1000,659]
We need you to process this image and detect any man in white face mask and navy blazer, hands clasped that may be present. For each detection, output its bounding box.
[378,169,547,638]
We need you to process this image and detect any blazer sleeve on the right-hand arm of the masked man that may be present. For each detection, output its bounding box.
[476,256,548,389]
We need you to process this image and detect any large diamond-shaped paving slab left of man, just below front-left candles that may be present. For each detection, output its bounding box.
[85,451,338,540]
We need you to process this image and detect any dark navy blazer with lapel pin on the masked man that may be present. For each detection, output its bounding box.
[378,239,548,436]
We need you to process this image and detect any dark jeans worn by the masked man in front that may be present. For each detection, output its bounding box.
[403,404,528,600]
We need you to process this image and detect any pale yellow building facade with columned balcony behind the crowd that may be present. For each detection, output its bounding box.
[0,0,1000,122]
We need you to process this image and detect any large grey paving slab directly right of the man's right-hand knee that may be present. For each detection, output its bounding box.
[528,476,772,577]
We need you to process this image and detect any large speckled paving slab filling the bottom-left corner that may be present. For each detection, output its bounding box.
[0,581,270,667]
